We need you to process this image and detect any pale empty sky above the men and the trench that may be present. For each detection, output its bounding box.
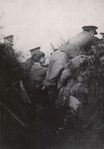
[0,0,104,57]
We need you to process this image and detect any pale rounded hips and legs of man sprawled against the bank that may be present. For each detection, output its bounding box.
[45,51,68,87]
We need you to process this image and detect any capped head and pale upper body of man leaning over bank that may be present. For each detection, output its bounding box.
[60,26,98,58]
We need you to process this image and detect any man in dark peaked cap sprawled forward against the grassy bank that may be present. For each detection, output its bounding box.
[45,26,98,87]
